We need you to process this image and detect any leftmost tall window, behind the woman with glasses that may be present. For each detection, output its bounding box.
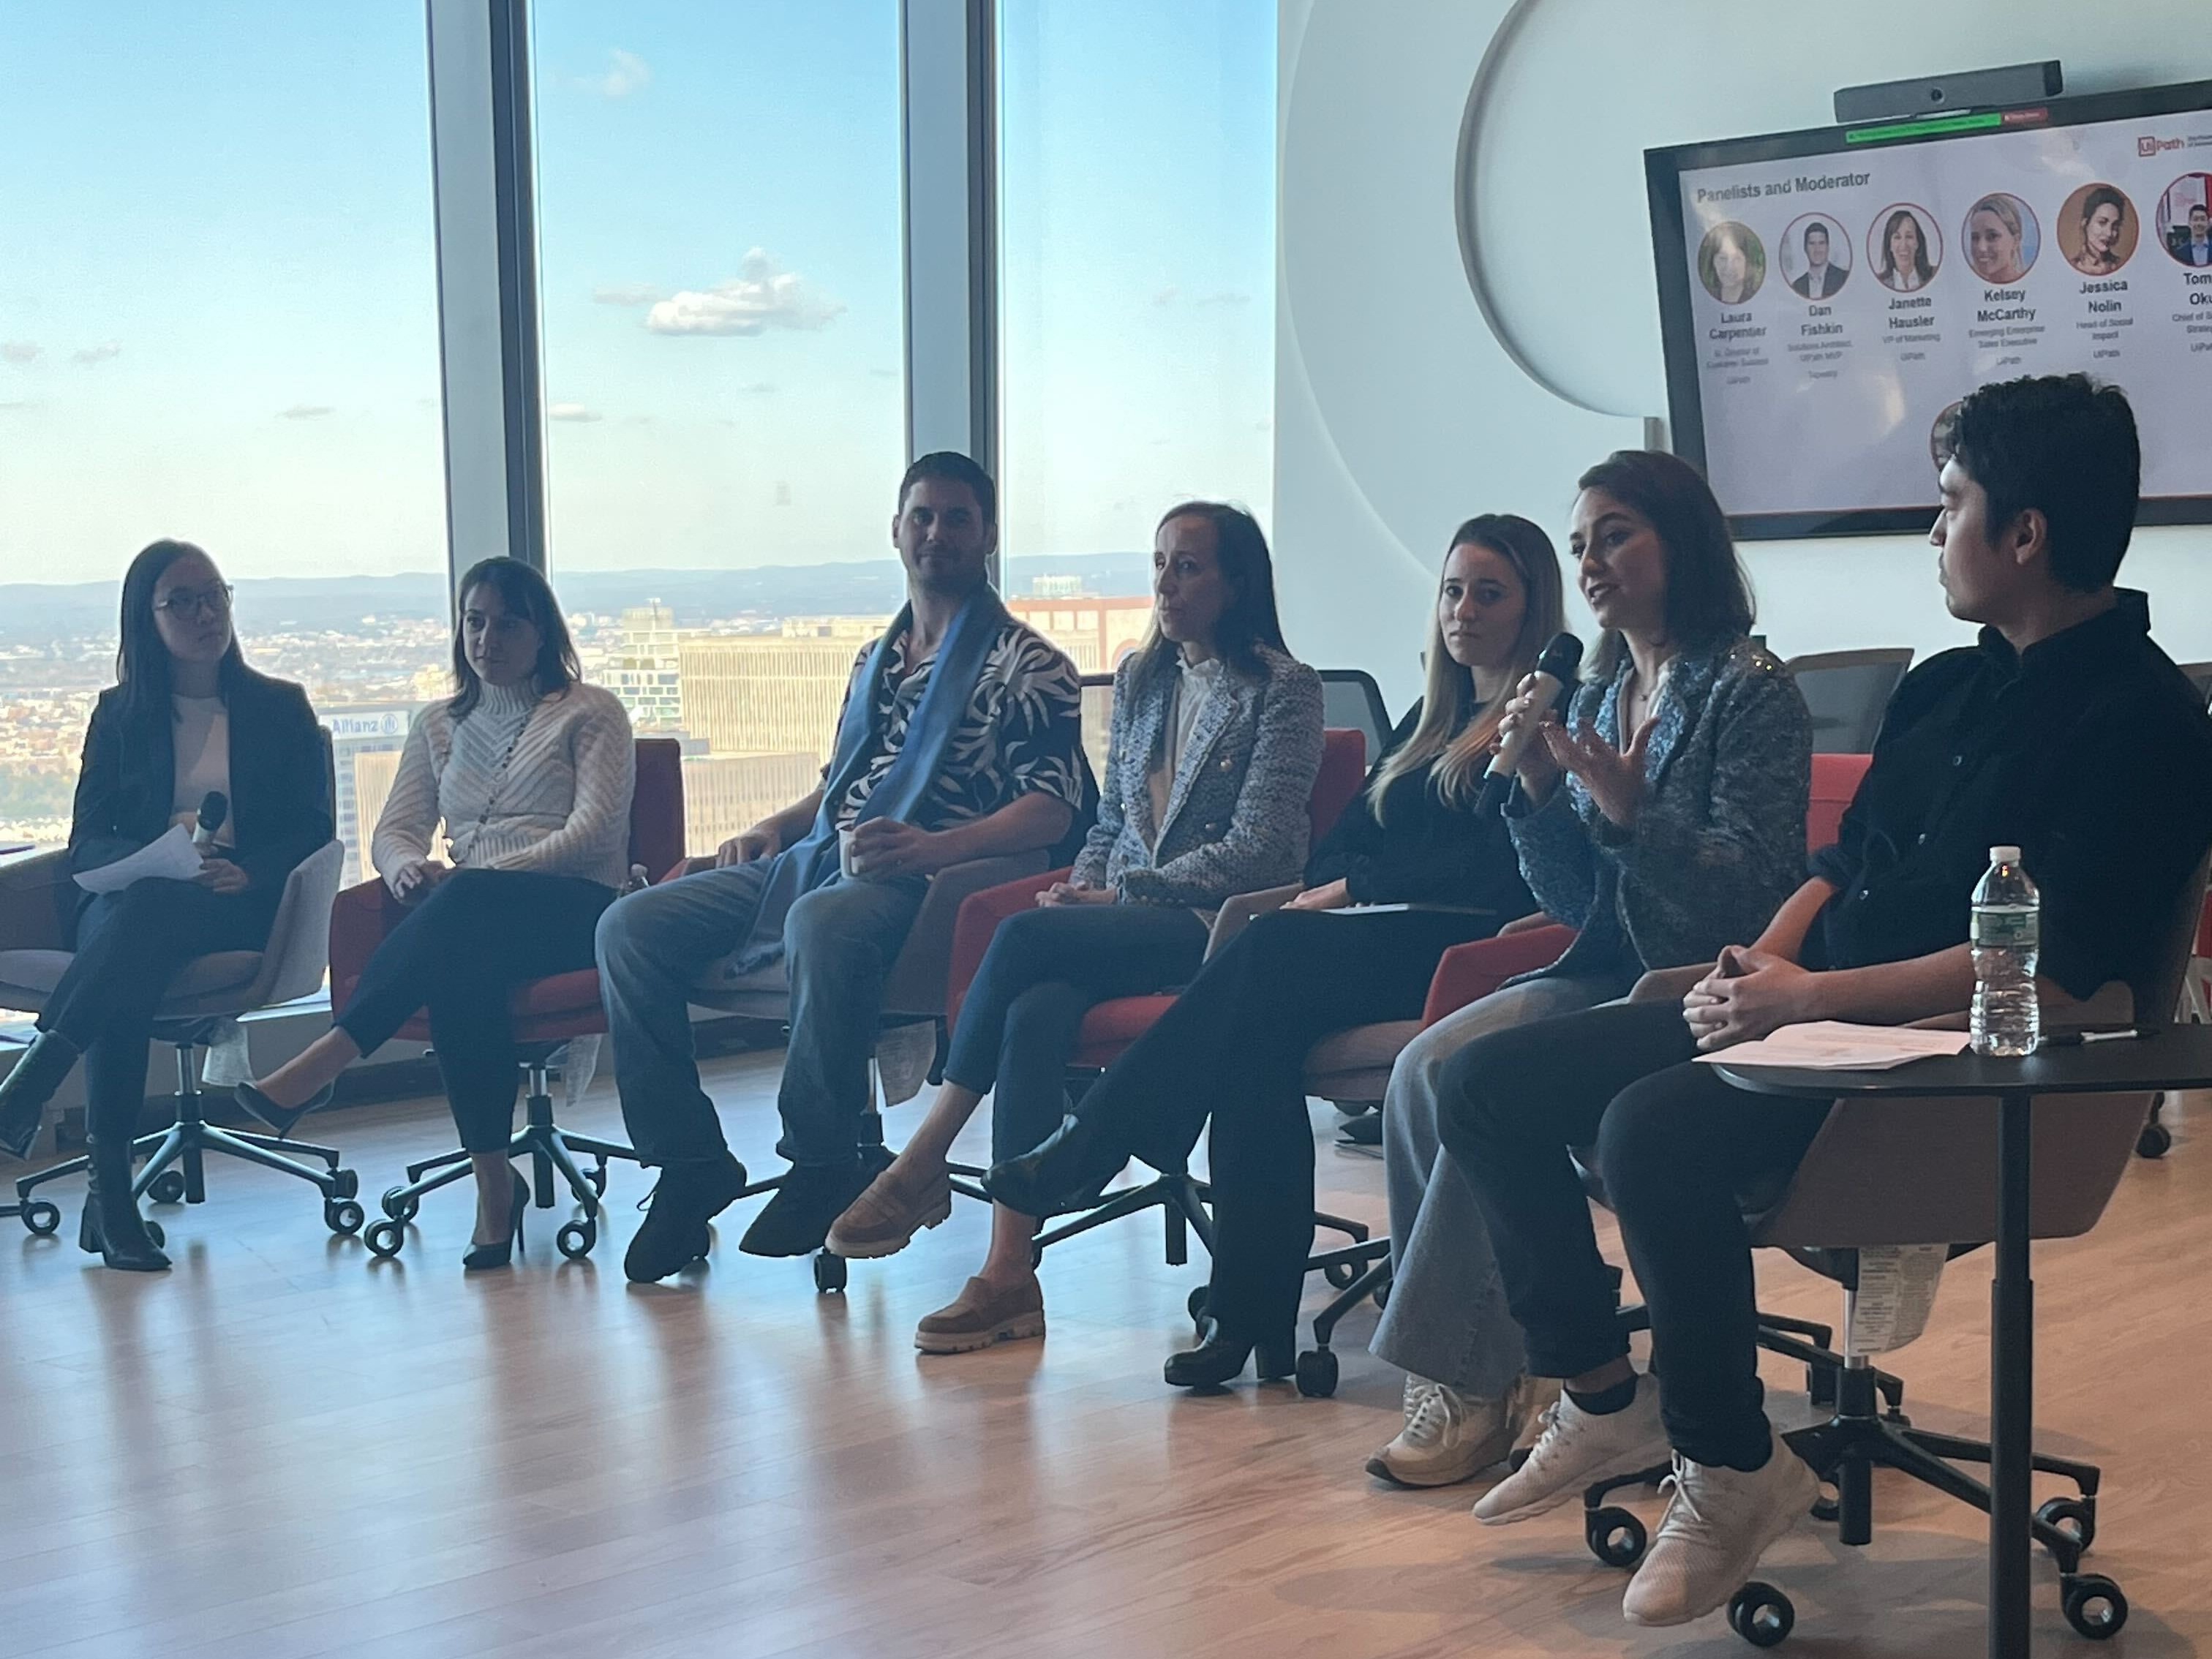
[0,0,447,889]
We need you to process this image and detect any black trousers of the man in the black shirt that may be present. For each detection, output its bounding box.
[1440,1002,1829,1469]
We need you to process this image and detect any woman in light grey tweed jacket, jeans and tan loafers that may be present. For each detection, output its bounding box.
[830,502,1320,1354]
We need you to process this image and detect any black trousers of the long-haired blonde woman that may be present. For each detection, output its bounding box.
[1077,909,1497,1336]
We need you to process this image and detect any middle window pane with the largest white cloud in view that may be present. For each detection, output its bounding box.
[531,0,905,849]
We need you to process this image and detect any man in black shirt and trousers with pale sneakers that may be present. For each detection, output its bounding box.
[1442,376,2212,1624]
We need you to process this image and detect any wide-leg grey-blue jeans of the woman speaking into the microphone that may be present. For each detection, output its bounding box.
[1369,974,1628,1400]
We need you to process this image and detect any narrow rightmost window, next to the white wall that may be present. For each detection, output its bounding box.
[998,0,1276,672]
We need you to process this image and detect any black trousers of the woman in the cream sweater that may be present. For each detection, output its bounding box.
[334,869,615,1153]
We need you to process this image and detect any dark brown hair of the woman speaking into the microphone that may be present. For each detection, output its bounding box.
[1575,449,1758,679]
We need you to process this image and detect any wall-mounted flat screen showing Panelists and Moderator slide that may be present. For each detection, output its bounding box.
[1644,82,2212,538]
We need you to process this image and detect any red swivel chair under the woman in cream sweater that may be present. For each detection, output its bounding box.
[330,737,683,1261]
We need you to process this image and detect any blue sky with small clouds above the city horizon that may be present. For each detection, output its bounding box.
[0,0,1274,597]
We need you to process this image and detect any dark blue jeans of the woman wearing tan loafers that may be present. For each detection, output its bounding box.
[944,905,1205,1164]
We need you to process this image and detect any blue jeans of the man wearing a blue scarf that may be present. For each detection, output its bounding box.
[597,858,929,1168]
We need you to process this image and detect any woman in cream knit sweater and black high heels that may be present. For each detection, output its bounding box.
[237,560,637,1270]
